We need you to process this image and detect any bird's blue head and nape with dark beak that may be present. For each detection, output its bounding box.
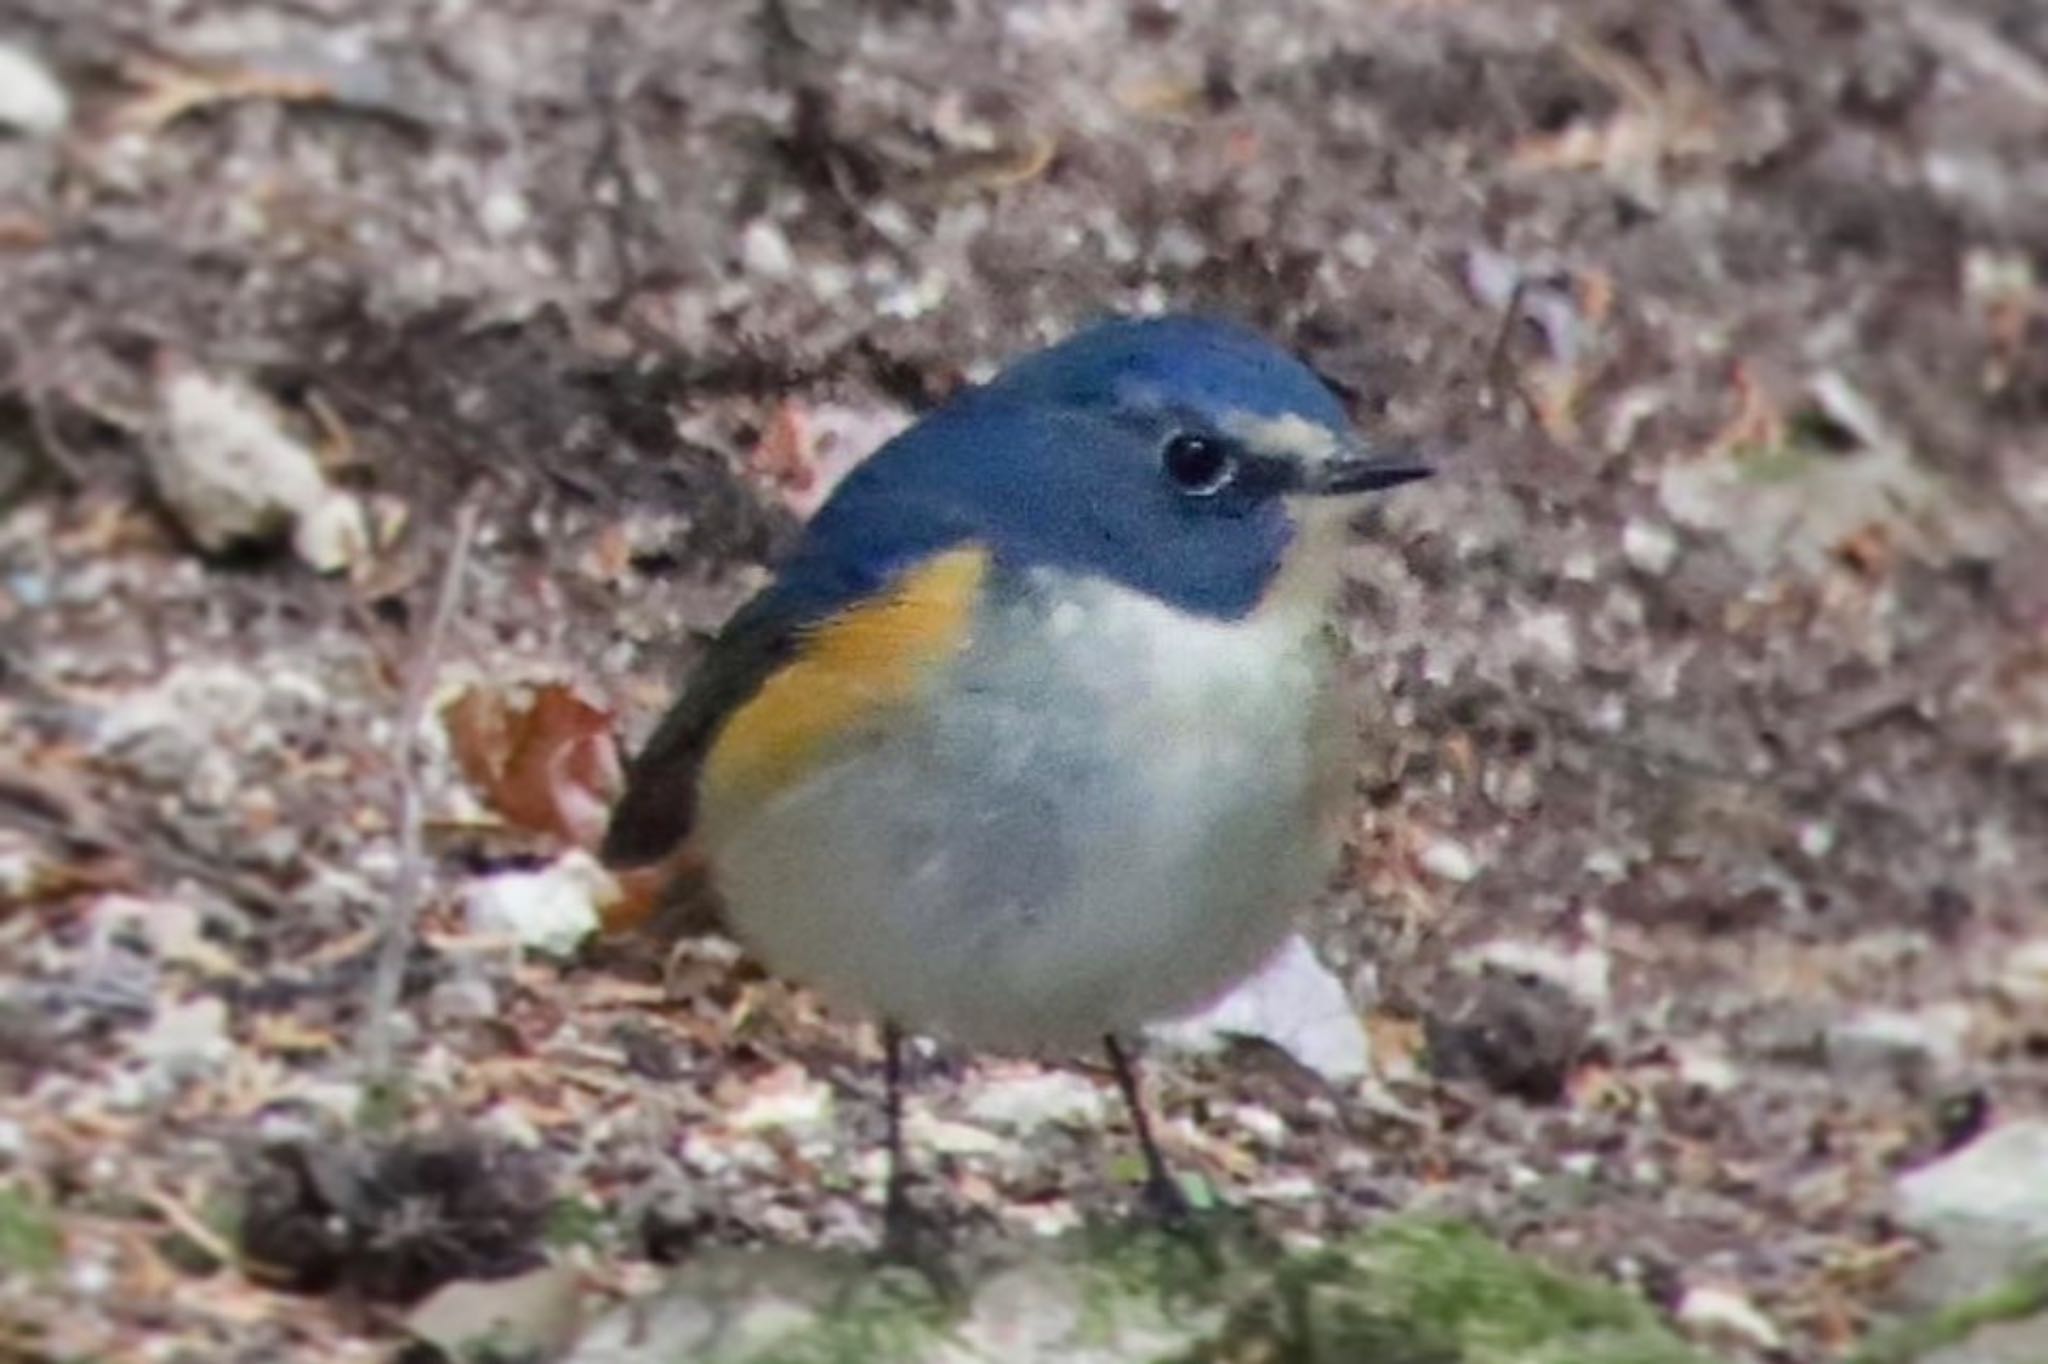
[791,317,1427,619]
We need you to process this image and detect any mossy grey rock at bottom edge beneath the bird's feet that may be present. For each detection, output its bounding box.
[565,1219,1704,1364]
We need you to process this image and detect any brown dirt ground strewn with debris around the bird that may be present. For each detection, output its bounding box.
[0,0,2048,1360]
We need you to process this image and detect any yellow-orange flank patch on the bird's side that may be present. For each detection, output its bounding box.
[702,549,989,801]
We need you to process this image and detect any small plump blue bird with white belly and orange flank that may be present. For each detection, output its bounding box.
[600,313,1430,1245]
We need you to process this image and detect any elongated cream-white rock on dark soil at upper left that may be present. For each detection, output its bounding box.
[145,360,369,573]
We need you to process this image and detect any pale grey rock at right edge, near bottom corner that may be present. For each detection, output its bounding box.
[1894,1118,2048,1303]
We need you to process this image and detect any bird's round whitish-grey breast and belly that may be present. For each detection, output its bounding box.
[711,552,1350,1051]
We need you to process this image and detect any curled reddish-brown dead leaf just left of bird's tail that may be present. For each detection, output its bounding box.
[440,682,625,848]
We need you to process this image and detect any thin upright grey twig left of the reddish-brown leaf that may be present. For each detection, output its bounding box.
[360,496,483,1085]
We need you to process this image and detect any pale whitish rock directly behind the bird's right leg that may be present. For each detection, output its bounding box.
[1149,936,1372,1083]
